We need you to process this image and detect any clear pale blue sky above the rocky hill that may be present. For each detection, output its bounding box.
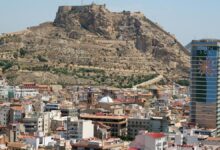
[0,0,220,45]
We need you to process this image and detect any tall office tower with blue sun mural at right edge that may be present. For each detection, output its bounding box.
[190,39,220,134]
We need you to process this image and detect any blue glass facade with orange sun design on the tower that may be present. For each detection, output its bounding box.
[191,46,218,103]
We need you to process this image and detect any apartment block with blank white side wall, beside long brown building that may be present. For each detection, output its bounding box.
[67,118,94,140]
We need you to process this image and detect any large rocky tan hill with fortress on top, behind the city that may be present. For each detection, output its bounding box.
[0,4,189,87]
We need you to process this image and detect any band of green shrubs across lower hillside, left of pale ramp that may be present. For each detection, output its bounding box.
[39,66,157,88]
